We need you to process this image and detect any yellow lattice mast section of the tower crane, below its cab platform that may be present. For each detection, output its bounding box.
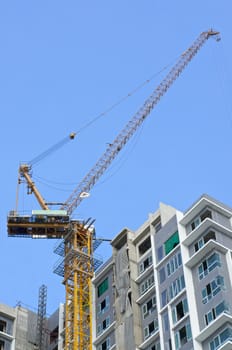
[54,221,102,350]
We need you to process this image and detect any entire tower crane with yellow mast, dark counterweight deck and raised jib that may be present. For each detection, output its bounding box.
[7,29,220,350]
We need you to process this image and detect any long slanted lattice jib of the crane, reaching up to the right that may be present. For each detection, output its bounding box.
[61,30,220,215]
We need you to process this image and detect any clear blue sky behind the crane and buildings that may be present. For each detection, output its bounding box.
[0,0,232,313]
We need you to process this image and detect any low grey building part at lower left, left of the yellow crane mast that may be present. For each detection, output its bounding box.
[0,303,64,350]
